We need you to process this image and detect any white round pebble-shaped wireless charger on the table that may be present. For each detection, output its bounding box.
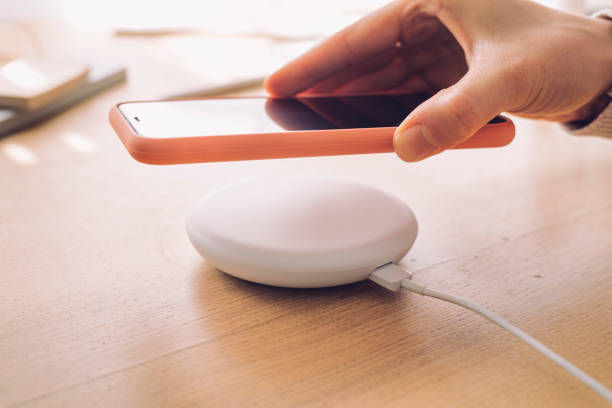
[187,176,417,288]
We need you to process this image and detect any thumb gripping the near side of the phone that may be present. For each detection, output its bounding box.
[393,70,503,162]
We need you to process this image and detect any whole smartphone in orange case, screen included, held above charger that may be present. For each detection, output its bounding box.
[110,94,514,164]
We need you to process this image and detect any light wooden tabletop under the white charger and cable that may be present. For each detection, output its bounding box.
[0,23,612,407]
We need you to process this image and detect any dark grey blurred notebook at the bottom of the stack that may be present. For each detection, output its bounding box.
[0,66,126,136]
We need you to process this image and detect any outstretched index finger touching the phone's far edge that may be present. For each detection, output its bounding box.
[265,2,401,95]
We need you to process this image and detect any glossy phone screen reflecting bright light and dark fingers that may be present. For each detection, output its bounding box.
[119,95,502,138]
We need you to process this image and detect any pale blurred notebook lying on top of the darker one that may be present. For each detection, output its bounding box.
[0,57,89,110]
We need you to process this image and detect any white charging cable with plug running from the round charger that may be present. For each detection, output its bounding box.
[369,263,612,405]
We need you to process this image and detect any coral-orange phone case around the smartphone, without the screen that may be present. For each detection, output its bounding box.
[109,98,514,164]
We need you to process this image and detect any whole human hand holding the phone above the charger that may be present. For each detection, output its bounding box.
[266,0,612,161]
